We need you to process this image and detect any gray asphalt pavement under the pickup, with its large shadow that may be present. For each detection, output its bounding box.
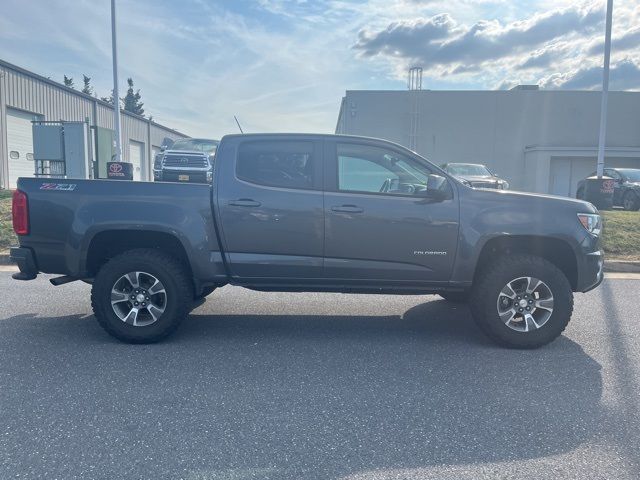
[0,267,640,480]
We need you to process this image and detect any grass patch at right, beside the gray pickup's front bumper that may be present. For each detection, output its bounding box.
[601,210,640,260]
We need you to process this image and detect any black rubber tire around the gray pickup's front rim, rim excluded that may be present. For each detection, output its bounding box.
[469,254,573,348]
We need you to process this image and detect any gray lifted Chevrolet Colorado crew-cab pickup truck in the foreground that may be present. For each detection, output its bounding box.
[11,134,603,348]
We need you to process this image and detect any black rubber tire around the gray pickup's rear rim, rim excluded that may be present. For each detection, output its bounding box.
[91,249,193,343]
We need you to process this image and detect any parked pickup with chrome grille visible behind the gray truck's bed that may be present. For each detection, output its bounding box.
[153,138,220,183]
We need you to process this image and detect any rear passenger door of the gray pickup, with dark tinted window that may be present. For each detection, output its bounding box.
[214,136,324,282]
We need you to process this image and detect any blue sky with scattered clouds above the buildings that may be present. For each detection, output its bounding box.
[0,0,640,138]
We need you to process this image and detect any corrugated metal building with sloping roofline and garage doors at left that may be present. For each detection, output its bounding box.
[0,60,186,188]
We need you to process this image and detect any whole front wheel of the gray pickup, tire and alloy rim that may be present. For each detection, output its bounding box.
[470,254,573,348]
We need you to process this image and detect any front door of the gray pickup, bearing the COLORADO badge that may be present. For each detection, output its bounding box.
[325,140,459,285]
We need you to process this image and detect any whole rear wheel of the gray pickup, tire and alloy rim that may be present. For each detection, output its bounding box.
[91,249,193,343]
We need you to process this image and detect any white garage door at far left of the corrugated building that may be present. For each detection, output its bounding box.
[7,108,38,188]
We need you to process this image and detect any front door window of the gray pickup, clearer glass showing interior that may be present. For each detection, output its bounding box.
[337,143,431,196]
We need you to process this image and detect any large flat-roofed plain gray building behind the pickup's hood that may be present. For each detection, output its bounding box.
[336,86,640,196]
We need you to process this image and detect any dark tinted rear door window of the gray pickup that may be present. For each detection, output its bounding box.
[236,141,314,189]
